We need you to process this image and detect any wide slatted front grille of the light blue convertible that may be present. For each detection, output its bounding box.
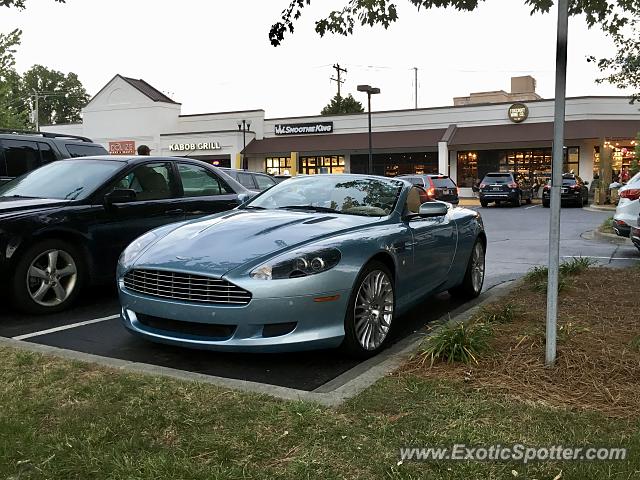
[124,269,251,305]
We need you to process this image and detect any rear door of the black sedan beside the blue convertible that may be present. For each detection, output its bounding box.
[175,162,240,219]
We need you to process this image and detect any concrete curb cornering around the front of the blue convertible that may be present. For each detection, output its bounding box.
[0,280,518,407]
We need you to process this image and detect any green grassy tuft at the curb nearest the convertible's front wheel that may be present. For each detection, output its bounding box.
[419,321,493,365]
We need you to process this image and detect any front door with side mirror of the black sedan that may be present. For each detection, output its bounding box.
[86,161,185,273]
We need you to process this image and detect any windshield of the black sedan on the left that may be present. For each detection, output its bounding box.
[0,159,123,200]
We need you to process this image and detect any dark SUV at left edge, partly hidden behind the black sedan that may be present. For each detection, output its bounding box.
[0,130,108,185]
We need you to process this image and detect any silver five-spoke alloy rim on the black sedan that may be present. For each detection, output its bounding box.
[26,250,78,307]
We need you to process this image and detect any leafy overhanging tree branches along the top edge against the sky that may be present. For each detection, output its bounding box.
[269,0,640,46]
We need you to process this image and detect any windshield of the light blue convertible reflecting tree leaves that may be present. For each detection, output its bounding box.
[244,175,404,217]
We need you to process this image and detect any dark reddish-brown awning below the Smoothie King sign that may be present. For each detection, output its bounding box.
[245,128,445,155]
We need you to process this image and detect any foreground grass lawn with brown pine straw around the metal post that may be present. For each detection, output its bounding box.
[0,269,640,480]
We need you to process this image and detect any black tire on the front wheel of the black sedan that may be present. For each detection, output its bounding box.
[11,239,87,315]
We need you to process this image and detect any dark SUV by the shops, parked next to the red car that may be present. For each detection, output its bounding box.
[478,172,533,207]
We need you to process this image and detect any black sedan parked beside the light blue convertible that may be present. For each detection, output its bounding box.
[0,156,255,313]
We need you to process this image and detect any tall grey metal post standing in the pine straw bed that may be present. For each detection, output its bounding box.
[545,0,569,367]
